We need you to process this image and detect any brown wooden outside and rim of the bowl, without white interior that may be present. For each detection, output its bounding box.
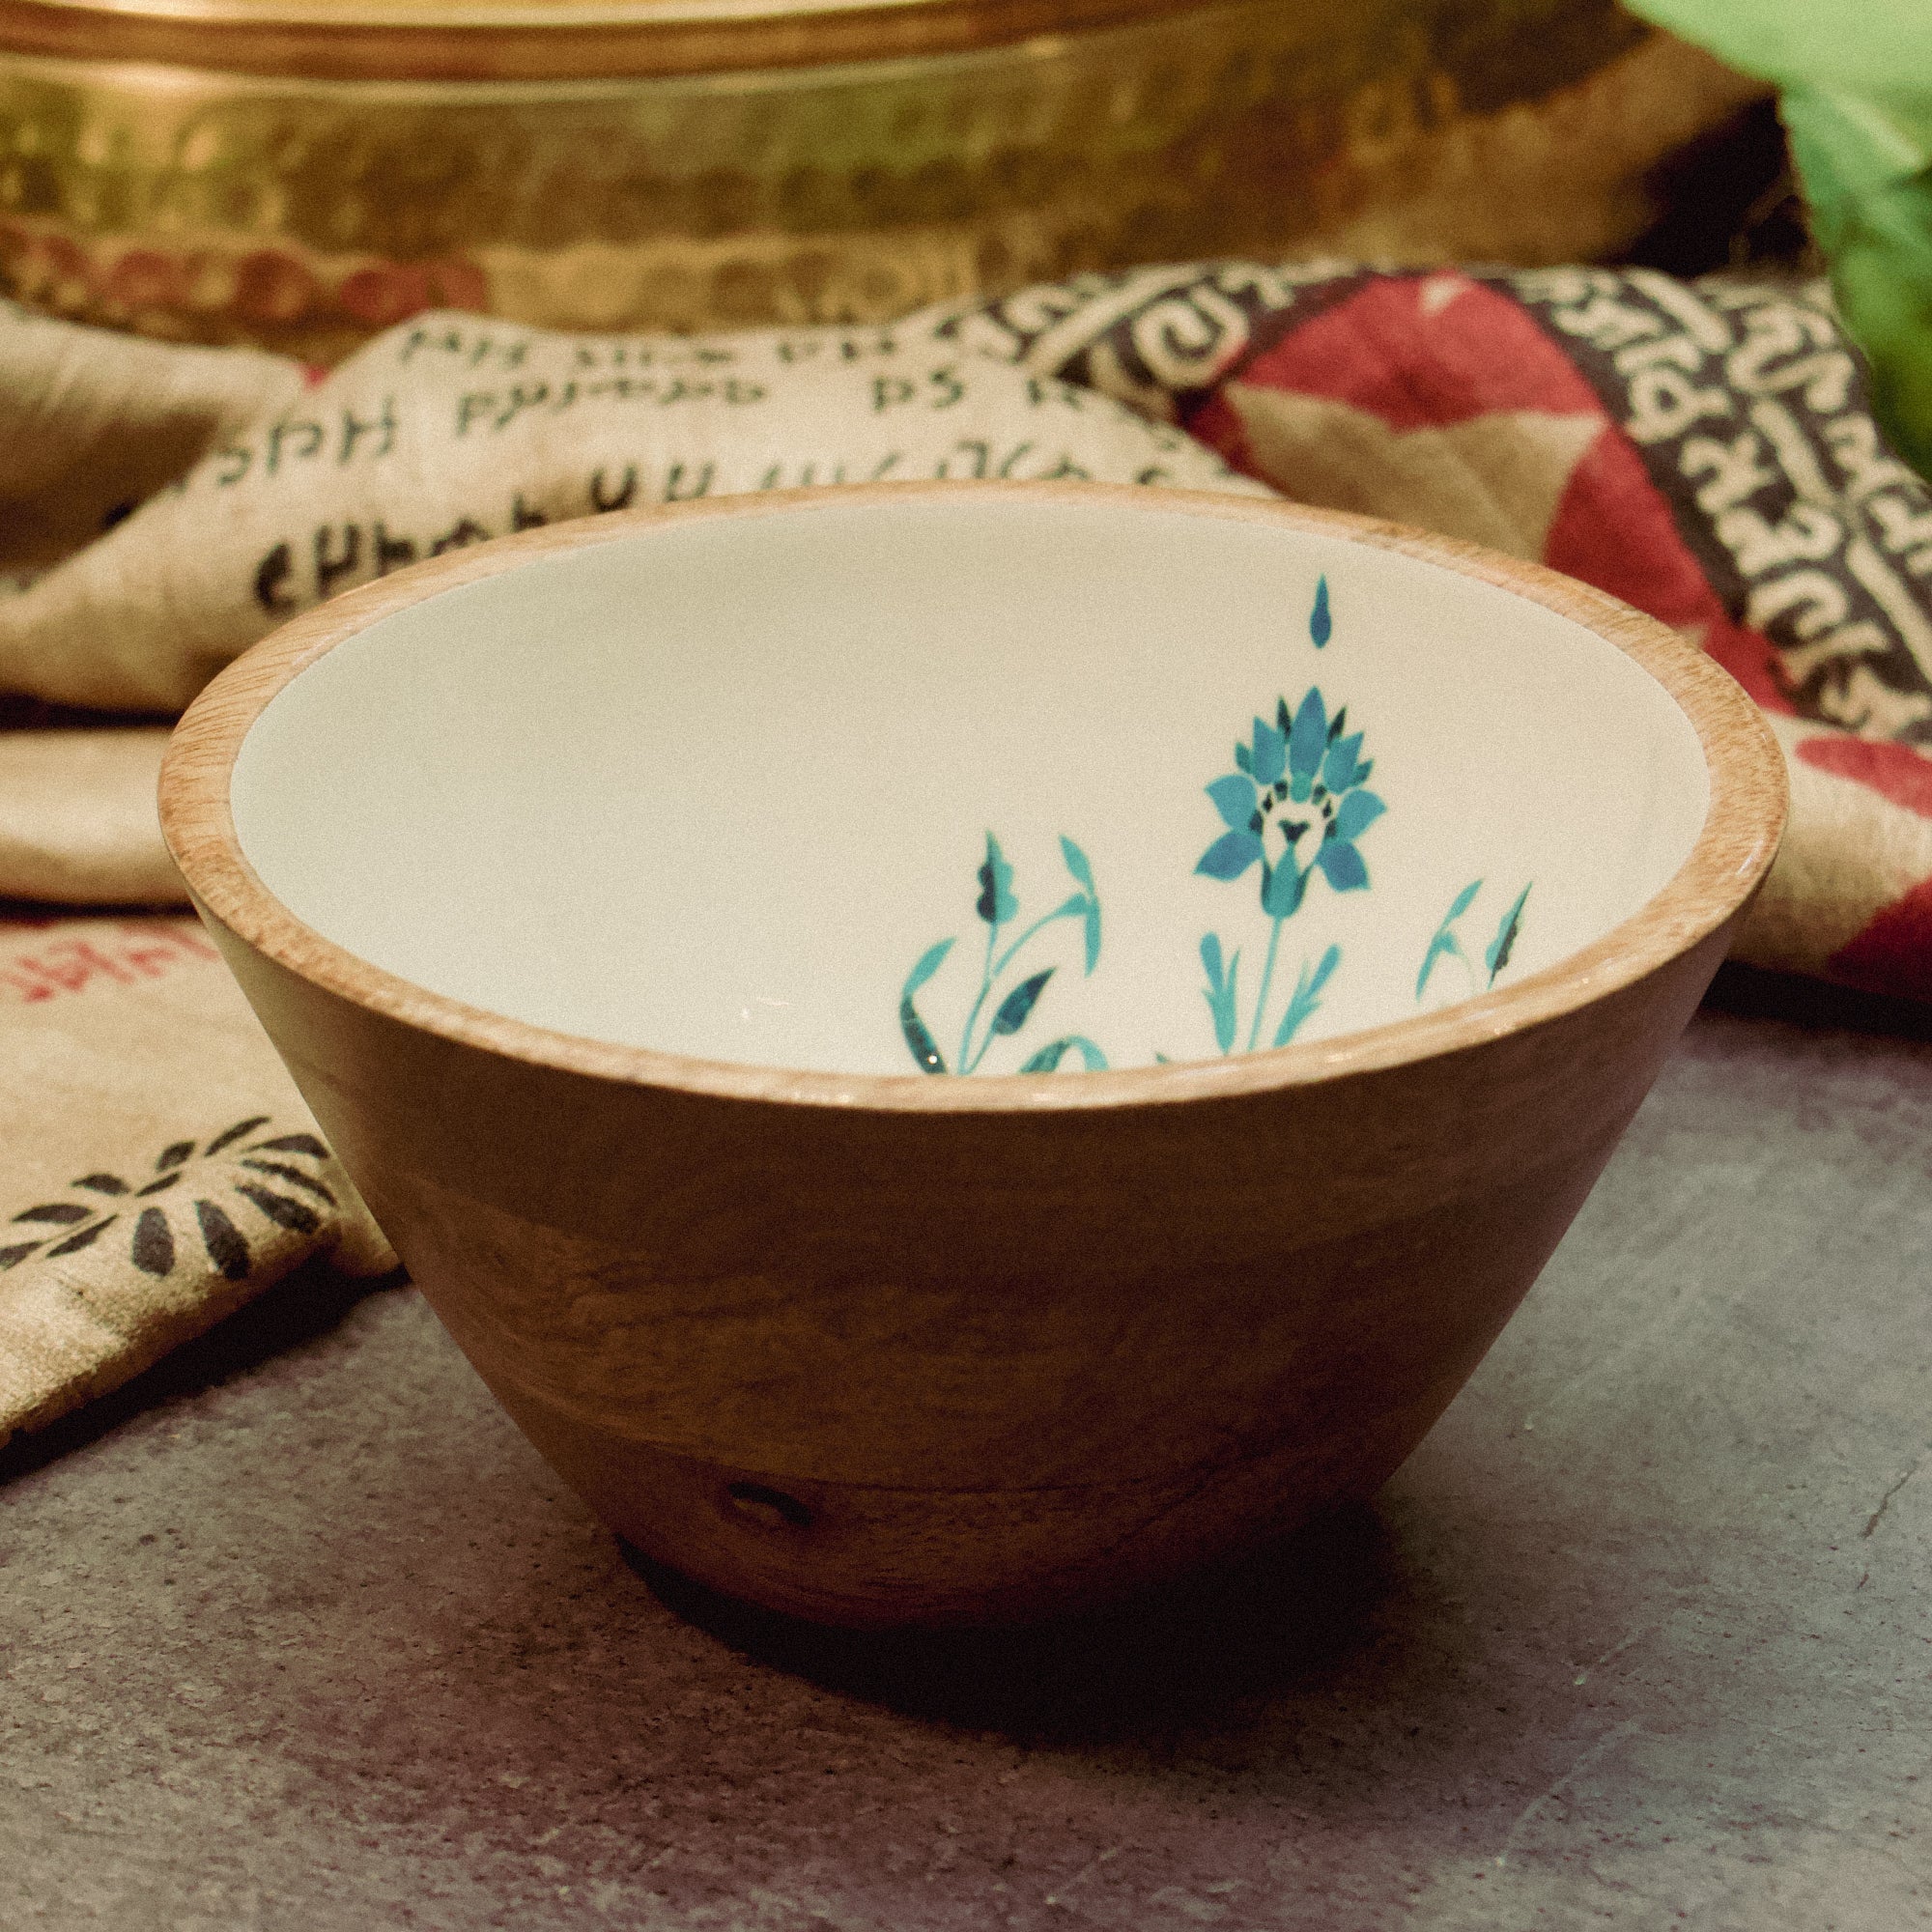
[162,485,1783,1625]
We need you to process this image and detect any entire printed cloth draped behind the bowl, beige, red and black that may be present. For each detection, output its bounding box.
[0,263,1932,1437]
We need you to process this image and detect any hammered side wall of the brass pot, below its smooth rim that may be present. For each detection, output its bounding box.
[0,0,1750,361]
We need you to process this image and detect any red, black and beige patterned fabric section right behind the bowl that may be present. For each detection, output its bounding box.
[960,265,1932,999]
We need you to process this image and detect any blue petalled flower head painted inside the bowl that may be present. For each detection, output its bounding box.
[1194,688,1385,920]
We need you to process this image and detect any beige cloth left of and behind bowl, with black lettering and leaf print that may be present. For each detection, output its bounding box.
[0,282,1260,1437]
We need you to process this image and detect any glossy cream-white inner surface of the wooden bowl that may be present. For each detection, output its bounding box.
[232,493,1708,1074]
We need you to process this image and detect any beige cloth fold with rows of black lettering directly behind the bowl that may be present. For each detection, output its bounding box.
[0,298,1258,711]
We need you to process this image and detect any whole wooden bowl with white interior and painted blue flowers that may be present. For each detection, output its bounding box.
[162,485,1783,1625]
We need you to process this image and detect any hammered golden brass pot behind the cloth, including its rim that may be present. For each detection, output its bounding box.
[0,0,1752,361]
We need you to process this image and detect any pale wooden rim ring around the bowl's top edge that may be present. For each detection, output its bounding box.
[160,481,1787,1115]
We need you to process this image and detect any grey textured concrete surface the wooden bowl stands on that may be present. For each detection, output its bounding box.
[0,978,1932,1932]
